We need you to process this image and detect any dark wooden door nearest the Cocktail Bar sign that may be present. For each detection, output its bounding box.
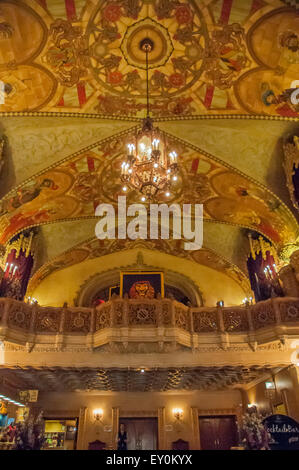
[199,416,237,450]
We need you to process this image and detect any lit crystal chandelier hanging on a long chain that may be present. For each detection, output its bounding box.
[121,38,179,198]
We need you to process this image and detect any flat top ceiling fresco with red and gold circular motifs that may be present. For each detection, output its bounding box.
[0,0,299,118]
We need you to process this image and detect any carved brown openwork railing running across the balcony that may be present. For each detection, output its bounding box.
[0,297,299,343]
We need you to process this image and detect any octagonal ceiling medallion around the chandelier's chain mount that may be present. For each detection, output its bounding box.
[120,18,174,70]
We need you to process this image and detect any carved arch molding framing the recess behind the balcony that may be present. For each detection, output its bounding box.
[74,252,204,307]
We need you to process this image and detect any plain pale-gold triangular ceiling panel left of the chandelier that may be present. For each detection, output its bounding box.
[0,117,132,197]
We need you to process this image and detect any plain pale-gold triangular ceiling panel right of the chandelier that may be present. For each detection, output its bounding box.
[159,119,298,204]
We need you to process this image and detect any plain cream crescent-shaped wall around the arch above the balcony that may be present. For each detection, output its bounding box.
[32,249,247,307]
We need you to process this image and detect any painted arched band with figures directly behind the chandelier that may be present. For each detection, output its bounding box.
[0,125,299,247]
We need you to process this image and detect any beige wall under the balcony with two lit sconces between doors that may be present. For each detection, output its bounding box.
[38,390,242,449]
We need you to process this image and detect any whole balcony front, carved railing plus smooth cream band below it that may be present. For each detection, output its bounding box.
[0,298,299,369]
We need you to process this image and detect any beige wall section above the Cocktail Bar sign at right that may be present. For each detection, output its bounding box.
[247,366,299,421]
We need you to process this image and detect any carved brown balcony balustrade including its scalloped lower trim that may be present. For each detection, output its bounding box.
[0,297,299,349]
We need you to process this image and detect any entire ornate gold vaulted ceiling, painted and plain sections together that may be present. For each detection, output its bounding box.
[0,0,299,303]
